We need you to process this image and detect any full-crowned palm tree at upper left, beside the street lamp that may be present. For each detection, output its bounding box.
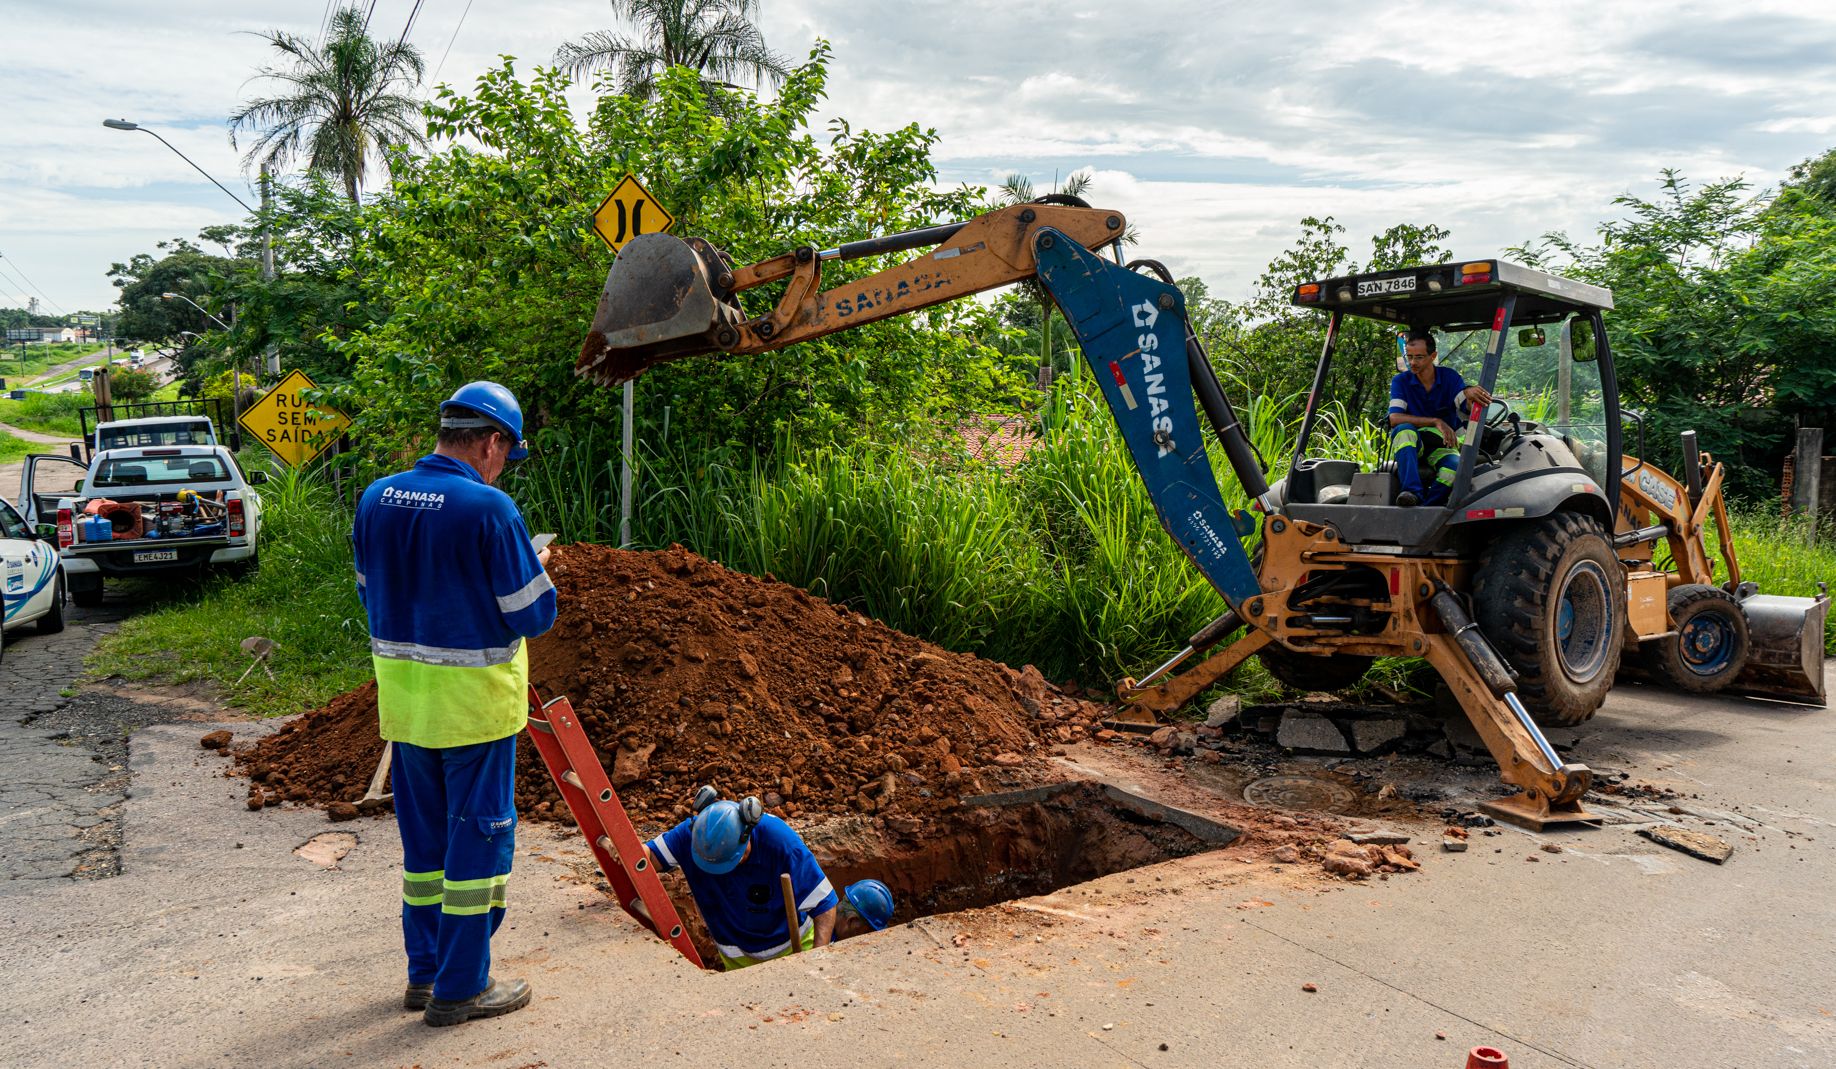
[230,7,428,202]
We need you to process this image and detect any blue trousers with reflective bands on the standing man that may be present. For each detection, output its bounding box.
[389,735,516,1001]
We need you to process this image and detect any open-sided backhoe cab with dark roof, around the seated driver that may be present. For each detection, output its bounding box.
[1272,259,1621,551]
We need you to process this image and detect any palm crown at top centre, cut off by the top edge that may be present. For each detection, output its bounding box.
[554,0,789,99]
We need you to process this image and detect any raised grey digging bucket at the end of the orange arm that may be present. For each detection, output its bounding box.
[575,233,744,386]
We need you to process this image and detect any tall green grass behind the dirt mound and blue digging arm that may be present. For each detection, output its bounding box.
[510,380,1384,681]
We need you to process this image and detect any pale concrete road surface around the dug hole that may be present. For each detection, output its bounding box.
[0,675,1836,1069]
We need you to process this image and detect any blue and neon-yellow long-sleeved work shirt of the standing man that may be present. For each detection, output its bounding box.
[351,454,554,748]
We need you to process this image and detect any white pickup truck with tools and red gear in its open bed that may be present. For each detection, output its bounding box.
[20,444,268,606]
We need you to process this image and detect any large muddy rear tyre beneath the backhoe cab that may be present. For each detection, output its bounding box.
[1472,512,1625,726]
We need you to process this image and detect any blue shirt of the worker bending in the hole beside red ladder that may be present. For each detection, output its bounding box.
[646,814,837,959]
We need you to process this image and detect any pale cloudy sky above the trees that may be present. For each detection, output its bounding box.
[0,0,1836,312]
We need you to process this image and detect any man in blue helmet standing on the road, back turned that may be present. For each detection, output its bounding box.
[351,382,554,1027]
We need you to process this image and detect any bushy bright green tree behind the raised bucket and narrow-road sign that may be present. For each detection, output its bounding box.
[336,46,1026,464]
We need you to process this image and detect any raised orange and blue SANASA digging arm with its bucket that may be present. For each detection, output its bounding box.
[575,204,1271,608]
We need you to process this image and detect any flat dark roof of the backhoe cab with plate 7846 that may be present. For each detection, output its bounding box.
[1291,259,1612,327]
